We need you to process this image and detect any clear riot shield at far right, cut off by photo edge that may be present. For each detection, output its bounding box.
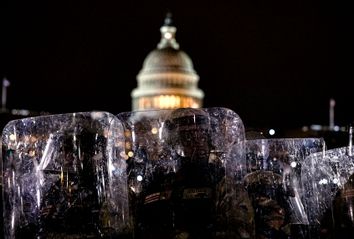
[302,147,354,238]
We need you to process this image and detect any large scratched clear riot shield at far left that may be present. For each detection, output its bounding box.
[2,112,130,238]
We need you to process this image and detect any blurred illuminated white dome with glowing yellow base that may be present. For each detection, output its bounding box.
[131,15,204,110]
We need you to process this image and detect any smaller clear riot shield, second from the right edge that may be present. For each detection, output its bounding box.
[244,138,325,238]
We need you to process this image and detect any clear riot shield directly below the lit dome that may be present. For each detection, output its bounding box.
[118,108,248,239]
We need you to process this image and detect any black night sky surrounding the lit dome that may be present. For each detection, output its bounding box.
[0,0,354,128]
